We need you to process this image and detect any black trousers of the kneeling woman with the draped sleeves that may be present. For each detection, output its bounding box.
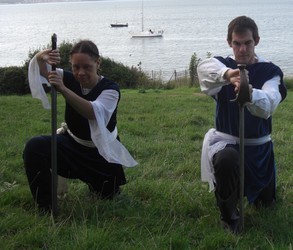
[23,134,126,207]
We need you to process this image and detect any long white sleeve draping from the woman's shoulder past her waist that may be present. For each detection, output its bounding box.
[89,90,138,167]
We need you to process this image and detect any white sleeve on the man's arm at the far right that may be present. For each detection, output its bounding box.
[247,76,282,119]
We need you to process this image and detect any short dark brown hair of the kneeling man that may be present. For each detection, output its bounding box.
[227,16,259,42]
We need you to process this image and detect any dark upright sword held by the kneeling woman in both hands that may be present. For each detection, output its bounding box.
[51,34,57,217]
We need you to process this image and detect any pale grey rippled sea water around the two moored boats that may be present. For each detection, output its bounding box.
[0,0,293,77]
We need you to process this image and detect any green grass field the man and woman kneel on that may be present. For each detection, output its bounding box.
[0,87,293,249]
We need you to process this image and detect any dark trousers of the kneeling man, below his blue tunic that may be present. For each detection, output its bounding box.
[213,145,275,220]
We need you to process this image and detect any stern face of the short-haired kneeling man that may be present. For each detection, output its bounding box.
[228,30,259,65]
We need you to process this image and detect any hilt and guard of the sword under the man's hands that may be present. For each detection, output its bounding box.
[231,64,251,106]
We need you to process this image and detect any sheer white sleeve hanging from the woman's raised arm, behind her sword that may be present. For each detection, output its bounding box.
[28,56,63,109]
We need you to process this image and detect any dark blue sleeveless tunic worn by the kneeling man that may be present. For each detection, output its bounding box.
[214,57,287,202]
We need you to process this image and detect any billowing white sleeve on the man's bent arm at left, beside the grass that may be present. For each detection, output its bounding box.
[197,58,229,96]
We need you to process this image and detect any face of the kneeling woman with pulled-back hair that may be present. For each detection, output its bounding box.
[71,53,100,88]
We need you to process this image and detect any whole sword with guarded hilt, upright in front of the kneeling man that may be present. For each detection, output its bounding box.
[232,64,251,232]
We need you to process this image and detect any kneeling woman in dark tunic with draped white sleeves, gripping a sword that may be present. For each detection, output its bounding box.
[23,40,137,211]
